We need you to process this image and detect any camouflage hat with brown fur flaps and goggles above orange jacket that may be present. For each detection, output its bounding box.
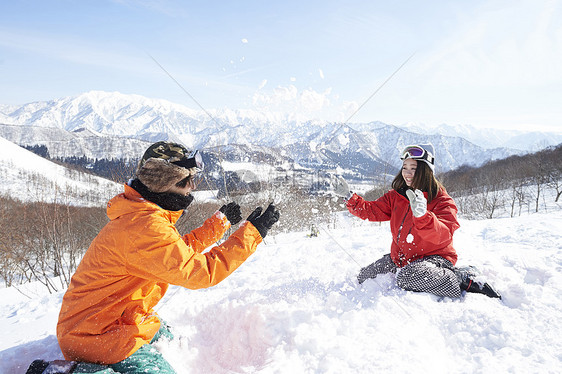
[136,141,197,193]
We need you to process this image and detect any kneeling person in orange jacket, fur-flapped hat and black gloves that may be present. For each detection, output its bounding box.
[57,142,279,373]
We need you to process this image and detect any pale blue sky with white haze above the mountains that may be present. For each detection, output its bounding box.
[0,0,562,131]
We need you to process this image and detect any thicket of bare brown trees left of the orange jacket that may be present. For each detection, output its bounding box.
[0,194,107,292]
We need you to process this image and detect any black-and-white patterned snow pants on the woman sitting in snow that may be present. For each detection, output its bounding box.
[357,254,461,298]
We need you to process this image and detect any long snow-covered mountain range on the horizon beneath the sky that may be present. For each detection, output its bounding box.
[0,91,536,175]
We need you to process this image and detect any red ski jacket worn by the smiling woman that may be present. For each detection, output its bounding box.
[347,188,460,267]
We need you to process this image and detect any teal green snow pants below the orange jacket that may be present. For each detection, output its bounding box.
[73,321,176,374]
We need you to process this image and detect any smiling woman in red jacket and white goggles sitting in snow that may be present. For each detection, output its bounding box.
[337,144,500,298]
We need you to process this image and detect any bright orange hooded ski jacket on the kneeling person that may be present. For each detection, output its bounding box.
[57,185,262,364]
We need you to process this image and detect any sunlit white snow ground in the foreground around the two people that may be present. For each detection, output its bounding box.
[0,205,562,374]
